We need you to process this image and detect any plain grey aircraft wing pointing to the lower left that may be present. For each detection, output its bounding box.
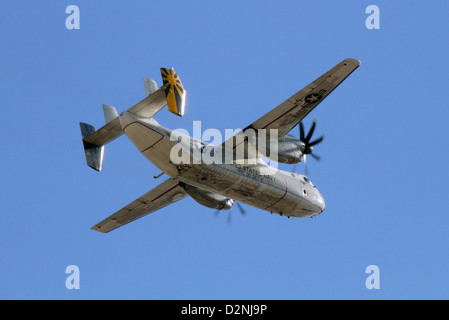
[91,178,187,233]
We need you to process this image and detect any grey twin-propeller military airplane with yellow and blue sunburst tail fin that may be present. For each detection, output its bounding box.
[80,58,360,233]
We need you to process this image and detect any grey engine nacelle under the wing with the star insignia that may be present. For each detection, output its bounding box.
[265,136,304,164]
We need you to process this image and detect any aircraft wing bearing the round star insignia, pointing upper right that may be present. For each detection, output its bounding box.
[222,59,360,146]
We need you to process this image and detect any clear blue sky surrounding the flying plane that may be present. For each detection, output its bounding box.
[0,0,449,299]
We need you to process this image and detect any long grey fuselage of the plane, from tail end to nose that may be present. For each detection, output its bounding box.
[120,112,325,217]
